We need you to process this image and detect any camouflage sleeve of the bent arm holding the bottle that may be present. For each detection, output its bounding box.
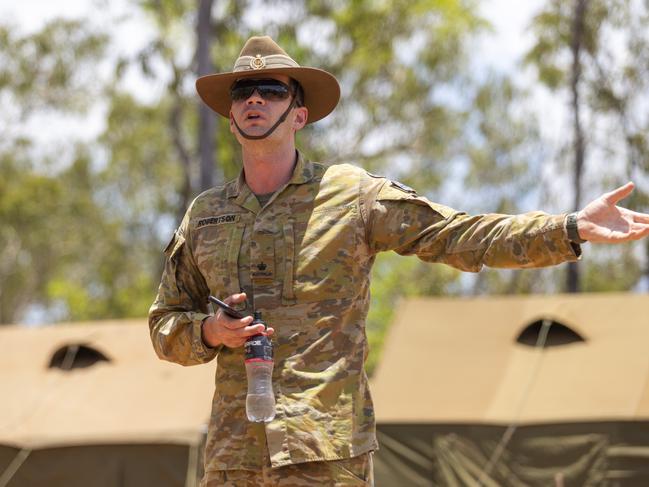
[149,211,220,365]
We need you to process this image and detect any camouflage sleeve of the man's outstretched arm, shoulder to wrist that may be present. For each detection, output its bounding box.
[364,178,581,272]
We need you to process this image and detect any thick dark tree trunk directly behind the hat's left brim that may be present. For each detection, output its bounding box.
[196,0,216,191]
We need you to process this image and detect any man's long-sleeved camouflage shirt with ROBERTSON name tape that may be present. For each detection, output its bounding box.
[149,152,578,472]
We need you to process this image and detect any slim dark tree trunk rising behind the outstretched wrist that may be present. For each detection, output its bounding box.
[566,0,588,293]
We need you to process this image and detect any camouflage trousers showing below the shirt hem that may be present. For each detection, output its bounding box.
[200,452,374,487]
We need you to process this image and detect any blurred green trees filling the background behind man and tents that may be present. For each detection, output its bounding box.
[0,0,649,370]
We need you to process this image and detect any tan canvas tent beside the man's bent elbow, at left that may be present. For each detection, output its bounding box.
[0,319,214,487]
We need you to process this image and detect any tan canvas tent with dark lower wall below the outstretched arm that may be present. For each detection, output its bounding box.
[372,294,649,487]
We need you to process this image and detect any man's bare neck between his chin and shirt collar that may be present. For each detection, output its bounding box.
[242,143,296,194]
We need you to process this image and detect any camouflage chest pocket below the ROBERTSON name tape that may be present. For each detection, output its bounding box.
[194,222,246,298]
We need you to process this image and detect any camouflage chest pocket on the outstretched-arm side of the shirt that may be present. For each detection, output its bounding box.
[282,205,362,304]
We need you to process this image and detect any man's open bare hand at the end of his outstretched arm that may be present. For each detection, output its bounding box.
[577,183,649,243]
